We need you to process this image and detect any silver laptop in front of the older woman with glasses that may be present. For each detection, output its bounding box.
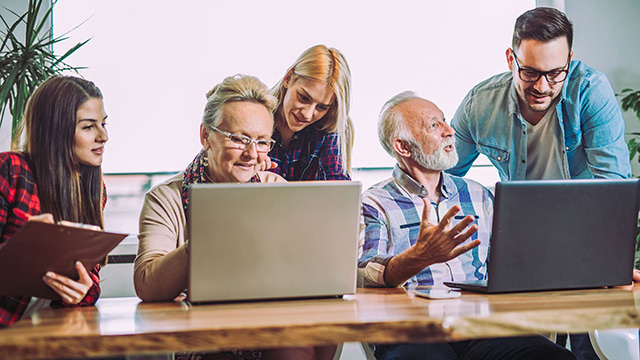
[188,181,361,303]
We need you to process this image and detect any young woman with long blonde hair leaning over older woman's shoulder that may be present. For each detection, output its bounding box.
[268,45,353,181]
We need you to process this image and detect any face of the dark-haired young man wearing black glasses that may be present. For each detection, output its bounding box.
[507,37,572,124]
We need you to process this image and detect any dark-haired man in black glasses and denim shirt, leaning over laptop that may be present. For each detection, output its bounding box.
[449,7,631,180]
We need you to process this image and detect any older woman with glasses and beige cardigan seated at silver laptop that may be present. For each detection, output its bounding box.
[134,75,335,359]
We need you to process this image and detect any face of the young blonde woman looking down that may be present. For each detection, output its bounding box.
[276,76,335,137]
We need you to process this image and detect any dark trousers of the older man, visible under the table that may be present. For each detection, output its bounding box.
[375,336,575,360]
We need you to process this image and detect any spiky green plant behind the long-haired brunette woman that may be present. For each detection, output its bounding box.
[0,0,89,146]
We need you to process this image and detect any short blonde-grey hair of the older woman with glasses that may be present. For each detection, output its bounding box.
[202,74,278,127]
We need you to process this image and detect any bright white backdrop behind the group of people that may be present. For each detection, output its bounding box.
[54,0,535,172]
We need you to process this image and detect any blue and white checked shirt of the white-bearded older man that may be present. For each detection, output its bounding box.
[358,165,493,287]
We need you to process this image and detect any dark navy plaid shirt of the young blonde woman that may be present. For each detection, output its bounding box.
[269,126,351,181]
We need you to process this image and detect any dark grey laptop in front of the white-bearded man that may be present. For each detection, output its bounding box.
[445,179,640,293]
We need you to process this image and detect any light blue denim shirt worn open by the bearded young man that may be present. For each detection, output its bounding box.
[448,61,631,181]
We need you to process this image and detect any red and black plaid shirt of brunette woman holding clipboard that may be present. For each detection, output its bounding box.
[0,152,104,328]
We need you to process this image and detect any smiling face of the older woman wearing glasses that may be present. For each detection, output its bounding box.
[200,101,273,182]
